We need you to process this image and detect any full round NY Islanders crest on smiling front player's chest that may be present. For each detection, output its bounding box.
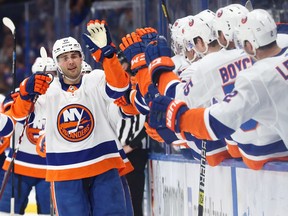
[57,104,94,142]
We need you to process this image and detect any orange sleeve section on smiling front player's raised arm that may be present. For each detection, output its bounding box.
[103,55,130,88]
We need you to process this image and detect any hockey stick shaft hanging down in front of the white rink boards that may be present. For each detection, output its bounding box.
[198,140,206,216]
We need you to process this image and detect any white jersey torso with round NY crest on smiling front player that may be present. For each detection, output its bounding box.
[35,70,128,181]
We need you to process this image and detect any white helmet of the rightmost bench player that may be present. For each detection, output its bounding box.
[235,9,277,53]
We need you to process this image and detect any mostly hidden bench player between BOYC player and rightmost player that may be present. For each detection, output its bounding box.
[214,4,288,170]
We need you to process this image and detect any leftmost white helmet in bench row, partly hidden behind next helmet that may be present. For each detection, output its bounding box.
[171,16,189,55]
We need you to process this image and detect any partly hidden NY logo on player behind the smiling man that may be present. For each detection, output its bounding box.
[26,112,44,145]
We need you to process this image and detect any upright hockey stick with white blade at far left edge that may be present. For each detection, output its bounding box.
[0,17,16,215]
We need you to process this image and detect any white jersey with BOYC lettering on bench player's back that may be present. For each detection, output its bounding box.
[165,49,253,166]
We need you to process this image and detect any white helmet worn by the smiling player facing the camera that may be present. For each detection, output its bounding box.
[52,37,84,65]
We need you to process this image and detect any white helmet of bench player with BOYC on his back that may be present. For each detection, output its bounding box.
[182,9,216,53]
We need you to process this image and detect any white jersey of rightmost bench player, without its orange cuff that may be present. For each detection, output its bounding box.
[204,52,288,150]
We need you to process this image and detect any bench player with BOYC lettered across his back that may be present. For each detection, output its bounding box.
[146,7,252,166]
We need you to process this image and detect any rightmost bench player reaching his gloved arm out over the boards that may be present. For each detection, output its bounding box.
[146,9,288,159]
